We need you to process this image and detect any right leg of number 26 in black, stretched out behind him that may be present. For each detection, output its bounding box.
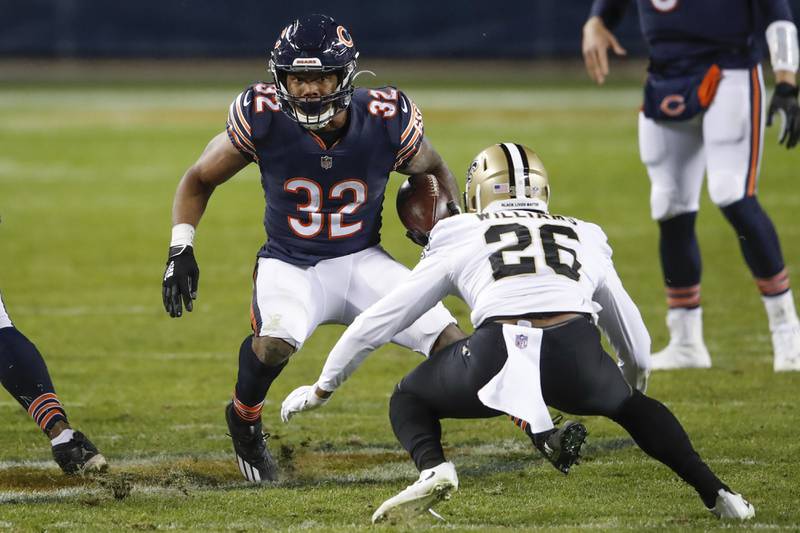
[539,320,752,518]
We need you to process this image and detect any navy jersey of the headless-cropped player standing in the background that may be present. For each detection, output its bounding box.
[590,0,792,76]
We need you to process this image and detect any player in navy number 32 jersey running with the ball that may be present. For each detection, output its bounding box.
[162,15,464,482]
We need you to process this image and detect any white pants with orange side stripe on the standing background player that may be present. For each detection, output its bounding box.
[639,65,765,220]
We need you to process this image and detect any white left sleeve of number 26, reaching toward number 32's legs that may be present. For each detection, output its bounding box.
[317,252,452,392]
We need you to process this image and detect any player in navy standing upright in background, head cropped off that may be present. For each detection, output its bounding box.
[583,0,800,372]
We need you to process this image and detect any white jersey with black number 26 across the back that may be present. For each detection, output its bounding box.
[412,210,627,327]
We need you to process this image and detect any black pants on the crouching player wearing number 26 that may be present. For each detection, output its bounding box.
[389,317,724,506]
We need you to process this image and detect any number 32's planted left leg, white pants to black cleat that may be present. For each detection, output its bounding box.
[225,258,326,482]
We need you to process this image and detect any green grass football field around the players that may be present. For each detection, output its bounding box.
[0,62,800,531]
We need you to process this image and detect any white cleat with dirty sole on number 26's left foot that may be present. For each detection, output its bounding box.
[372,462,458,524]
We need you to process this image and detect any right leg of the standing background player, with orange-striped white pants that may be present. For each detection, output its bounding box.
[703,67,800,372]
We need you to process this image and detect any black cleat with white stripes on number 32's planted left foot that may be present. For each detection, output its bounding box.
[225,402,278,483]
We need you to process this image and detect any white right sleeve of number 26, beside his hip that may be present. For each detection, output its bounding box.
[593,227,650,372]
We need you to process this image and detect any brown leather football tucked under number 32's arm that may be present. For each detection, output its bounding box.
[397,174,453,245]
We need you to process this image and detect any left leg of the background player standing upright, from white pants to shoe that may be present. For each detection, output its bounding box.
[639,113,711,370]
